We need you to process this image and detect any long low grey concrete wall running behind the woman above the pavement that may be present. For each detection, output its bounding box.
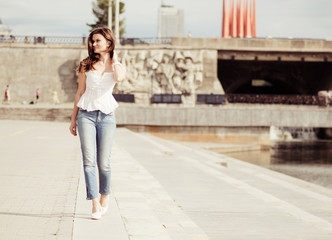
[0,104,332,128]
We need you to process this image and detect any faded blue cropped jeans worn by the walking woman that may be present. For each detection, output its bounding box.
[77,109,116,200]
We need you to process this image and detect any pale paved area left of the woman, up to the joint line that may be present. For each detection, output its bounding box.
[0,120,80,240]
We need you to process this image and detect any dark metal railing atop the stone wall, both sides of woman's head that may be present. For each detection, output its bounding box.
[0,35,172,45]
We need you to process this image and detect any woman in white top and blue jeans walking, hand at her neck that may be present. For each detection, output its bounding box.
[70,27,126,219]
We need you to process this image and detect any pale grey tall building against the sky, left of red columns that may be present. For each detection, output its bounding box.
[158,4,184,38]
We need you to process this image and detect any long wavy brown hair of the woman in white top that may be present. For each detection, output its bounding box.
[78,27,115,73]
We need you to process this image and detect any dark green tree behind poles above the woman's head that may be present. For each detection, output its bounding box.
[87,0,126,38]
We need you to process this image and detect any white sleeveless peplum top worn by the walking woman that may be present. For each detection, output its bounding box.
[77,71,119,114]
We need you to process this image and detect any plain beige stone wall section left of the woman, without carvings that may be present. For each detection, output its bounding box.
[0,44,84,103]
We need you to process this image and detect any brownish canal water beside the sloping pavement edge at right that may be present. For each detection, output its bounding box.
[223,140,332,189]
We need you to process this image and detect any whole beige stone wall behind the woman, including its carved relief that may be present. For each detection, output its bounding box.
[0,44,224,106]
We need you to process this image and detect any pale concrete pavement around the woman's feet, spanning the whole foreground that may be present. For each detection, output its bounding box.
[0,120,332,240]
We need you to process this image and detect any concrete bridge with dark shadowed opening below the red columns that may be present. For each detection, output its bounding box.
[172,38,332,95]
